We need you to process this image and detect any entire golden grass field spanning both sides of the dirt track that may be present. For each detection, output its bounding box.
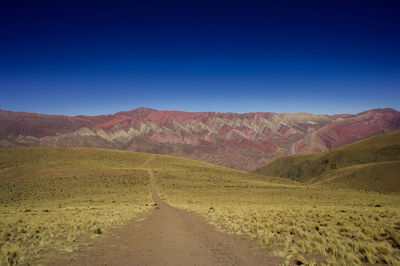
[0,148,400,265]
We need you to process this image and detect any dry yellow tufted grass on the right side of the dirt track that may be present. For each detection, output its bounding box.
[151,156,400,265]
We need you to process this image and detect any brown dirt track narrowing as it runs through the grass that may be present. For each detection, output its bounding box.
[54,161,283,265]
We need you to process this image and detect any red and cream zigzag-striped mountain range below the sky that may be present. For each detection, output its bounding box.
[0,108,400,171]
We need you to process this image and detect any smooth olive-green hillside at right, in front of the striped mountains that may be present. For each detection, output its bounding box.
[255,130,400,192]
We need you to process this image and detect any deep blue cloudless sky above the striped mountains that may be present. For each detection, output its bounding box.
[0,0,400,115]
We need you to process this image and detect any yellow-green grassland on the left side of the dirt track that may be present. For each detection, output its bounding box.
[0,148,153,265]
